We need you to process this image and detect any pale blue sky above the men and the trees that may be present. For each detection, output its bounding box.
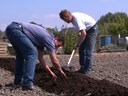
[0,0,128,31]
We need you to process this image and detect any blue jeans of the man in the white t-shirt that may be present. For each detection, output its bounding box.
[79,25,98,72]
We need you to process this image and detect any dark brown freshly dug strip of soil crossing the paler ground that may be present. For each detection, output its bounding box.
[0,58,128,96]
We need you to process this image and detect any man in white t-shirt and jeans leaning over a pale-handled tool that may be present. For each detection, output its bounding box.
[59,9,98,74]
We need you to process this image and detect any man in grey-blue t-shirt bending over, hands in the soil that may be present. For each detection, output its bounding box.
[6,22,66,90]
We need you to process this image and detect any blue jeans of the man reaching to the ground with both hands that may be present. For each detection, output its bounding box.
[6,23,37,86]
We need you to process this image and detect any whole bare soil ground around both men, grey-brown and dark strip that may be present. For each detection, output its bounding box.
[0,52,128,96]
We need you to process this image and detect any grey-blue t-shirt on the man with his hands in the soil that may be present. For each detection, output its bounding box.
[20,23,55,51]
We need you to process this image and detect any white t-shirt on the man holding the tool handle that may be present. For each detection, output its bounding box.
[71,12,96,31]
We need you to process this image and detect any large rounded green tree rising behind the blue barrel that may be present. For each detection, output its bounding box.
[98,12,128,35]
